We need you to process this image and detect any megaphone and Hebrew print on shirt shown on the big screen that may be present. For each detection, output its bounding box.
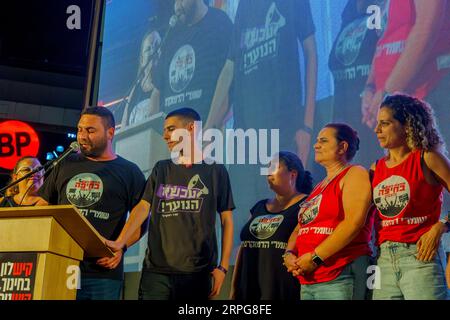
[242,2,286,74]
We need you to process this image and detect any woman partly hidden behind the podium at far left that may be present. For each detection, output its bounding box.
[0,156,43,207]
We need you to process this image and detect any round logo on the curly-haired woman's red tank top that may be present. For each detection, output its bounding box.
[373,175,410,218]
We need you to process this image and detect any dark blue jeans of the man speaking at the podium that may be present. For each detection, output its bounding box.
[77,277,123,300]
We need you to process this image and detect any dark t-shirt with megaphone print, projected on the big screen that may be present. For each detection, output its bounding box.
[228,0,315,129]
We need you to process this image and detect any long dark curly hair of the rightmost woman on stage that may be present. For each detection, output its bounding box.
[380,94,446,153]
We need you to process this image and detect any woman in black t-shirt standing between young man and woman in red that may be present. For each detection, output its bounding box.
[231,151,312,300]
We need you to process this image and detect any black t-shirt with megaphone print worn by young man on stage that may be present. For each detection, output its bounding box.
[142,160,234,274]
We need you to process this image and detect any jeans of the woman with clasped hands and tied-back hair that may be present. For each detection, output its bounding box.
[300,256,370,300]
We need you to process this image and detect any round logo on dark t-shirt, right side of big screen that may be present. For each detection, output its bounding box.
[336,17,368,66]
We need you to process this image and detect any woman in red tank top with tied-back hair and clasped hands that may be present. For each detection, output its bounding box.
[284,123,373,300]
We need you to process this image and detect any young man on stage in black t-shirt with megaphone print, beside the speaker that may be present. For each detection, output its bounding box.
[107,108,234,300]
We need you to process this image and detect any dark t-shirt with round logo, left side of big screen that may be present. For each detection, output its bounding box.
[153,8,232,121]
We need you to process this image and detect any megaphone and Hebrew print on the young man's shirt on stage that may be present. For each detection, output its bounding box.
[156,174,209,216]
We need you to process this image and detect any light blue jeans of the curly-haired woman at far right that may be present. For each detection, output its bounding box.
[373,241,447,300]
